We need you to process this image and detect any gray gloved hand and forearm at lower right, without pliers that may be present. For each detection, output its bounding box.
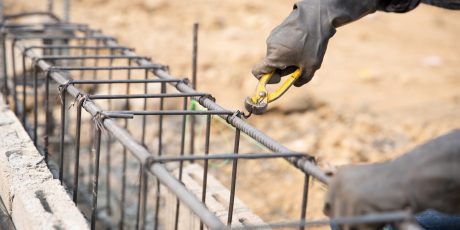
[324,130,460,228]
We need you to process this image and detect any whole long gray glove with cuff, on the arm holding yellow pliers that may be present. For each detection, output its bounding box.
[252,0,419,87]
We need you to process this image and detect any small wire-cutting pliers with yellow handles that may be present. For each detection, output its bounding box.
[245,69,302,115]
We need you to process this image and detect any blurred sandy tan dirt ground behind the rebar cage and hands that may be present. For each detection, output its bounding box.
[6,0,460,226]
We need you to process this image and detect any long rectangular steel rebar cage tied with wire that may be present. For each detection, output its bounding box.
[1,1,414,229]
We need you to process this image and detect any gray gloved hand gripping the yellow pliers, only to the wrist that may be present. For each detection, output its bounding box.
[252,0,335,87]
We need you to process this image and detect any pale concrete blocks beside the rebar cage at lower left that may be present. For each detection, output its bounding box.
[0,100,89,230]
